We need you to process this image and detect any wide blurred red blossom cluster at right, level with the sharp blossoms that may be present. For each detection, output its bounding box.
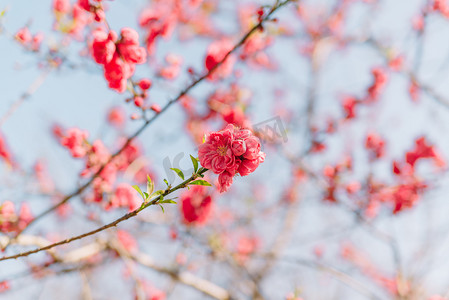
[323,133,445,218]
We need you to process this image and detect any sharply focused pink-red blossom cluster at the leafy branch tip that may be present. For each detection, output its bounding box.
[198,124,265,193]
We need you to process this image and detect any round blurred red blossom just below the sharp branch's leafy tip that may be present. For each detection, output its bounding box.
[181,186,212,225]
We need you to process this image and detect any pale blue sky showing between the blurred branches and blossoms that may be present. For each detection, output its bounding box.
[0,0,449,299]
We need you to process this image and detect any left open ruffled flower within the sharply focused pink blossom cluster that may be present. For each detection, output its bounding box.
[198,125,235,174]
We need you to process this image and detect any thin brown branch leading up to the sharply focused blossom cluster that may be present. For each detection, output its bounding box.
[0,168,208,261]
